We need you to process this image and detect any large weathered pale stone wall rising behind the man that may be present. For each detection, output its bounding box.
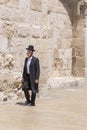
[0,0,85,90]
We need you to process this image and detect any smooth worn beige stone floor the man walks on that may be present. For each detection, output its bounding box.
[0,88,87,130]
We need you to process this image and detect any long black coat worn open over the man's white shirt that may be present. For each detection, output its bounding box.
[23,56,40,93]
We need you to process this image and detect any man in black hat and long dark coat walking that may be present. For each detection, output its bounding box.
[22,45,40,106]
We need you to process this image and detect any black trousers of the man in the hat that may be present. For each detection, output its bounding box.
[24,74,36,104]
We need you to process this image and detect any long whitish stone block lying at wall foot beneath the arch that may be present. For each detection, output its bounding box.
[47,77,86,88]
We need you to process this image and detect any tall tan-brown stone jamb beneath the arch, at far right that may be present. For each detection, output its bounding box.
[72,1,85,77]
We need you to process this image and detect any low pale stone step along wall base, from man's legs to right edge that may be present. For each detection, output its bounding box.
[38,77,86,98]
